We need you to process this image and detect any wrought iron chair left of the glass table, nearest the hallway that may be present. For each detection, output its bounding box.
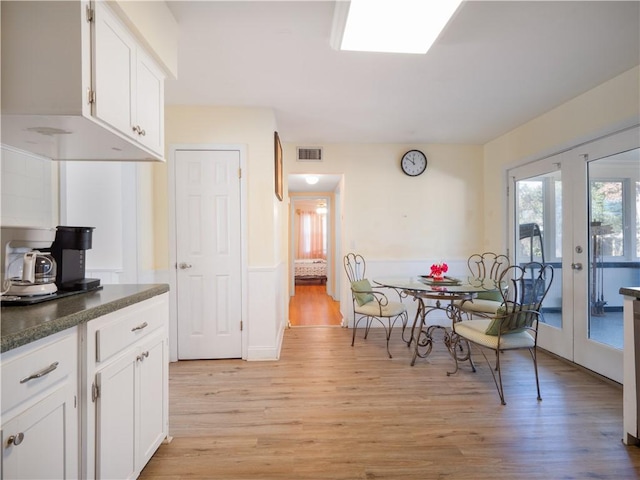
[344,253,408,358]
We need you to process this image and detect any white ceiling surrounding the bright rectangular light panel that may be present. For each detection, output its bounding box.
[166,0,640,146]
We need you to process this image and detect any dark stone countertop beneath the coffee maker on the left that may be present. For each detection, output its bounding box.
[0,283,169,353]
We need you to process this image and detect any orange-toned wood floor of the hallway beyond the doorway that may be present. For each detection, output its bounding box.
[289,285,342,327]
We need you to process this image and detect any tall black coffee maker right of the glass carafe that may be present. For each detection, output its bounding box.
[51,226,100,292]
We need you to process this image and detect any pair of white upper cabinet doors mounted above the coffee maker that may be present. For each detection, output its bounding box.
[93,2,164,155]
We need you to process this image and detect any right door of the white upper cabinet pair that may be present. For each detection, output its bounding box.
[135,49,164,155]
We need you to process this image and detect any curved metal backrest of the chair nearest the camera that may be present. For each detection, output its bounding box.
[496,262,553,334]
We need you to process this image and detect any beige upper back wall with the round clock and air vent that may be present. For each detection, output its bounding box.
[284,144,483,260]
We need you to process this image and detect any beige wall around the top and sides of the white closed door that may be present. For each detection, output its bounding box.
[154,106,284,270]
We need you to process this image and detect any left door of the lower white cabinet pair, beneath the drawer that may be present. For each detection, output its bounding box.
[96,353,136,479]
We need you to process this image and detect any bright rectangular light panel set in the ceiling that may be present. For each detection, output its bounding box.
[331,0,462,53]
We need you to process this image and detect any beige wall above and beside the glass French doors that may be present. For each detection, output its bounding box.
[482,67,640,251]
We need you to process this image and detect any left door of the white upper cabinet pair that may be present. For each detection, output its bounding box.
[93,2,136,137]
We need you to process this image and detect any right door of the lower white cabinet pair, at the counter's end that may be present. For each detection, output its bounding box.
[138,337,168,469]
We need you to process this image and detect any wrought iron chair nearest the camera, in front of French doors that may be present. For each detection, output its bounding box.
[447,262,553,405]
